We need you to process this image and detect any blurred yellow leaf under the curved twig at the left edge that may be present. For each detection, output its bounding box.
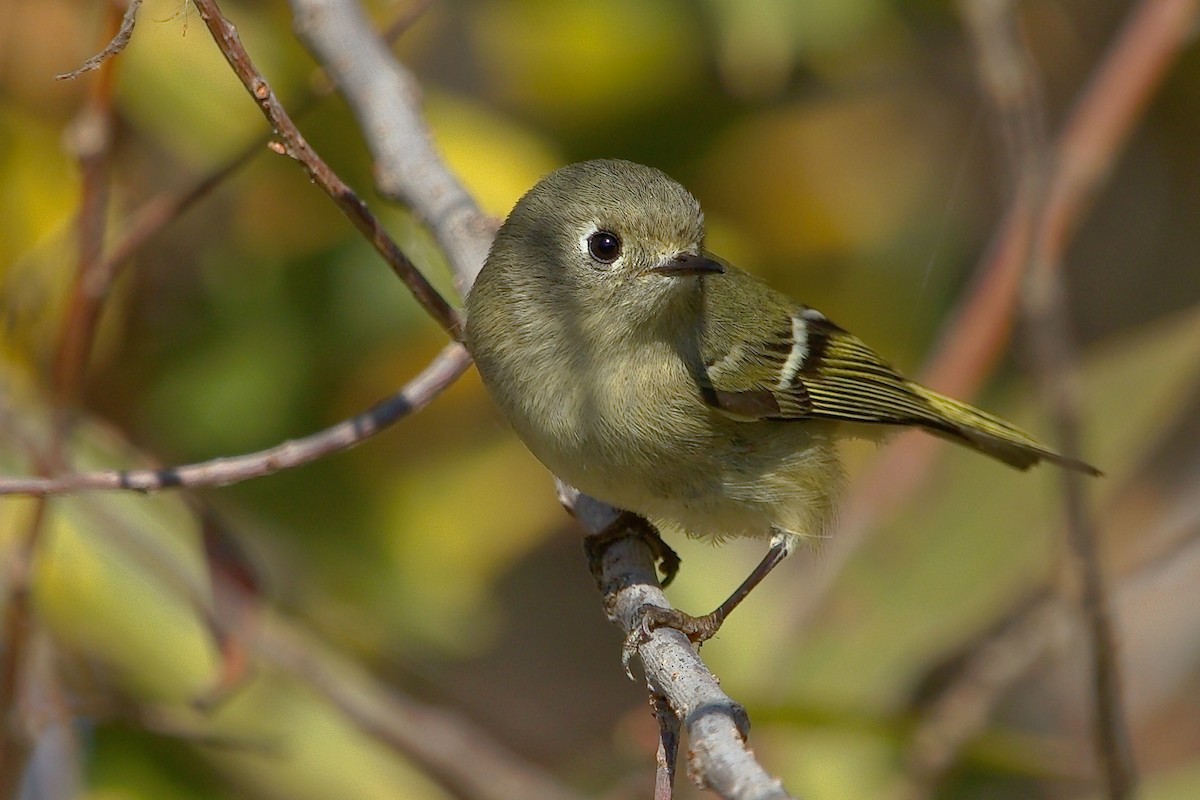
[0,400,223,702]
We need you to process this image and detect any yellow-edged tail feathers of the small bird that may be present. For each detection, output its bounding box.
[912,384,1102,475]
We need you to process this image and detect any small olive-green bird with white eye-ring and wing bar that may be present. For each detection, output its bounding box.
[467,161,1098,639]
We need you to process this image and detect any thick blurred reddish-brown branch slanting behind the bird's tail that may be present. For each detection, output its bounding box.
[787,0,1200,631]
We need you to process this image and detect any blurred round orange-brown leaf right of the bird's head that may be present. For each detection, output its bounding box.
[697,92,944,260]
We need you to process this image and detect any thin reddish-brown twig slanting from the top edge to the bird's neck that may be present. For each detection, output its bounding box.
[194,0,462,339]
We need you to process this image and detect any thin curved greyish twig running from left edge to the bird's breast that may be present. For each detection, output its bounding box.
[0,343,470,497]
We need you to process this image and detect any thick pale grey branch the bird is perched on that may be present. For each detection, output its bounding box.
[285,0,788,800]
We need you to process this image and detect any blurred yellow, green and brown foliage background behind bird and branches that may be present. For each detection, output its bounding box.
[0,0,1200,800]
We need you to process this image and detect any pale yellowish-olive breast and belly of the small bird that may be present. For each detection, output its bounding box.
[476,323,841,539]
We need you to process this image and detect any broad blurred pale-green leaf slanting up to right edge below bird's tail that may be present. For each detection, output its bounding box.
[729,304,1200,708]
